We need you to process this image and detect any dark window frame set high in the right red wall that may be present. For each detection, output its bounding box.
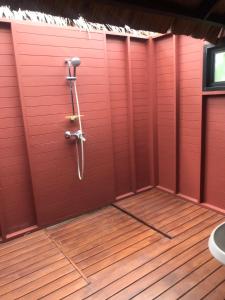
[203,44,225,91]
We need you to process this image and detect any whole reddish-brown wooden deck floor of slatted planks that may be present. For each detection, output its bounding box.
[0,189,225,300]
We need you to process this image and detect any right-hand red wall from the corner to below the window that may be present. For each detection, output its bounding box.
[153,35,225,212]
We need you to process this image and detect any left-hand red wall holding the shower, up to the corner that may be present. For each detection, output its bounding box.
[0,22,153,239]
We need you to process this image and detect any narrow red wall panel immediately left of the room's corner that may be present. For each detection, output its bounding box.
[130,39,152,189]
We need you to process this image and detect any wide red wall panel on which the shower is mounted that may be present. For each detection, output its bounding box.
[13,24,114,225]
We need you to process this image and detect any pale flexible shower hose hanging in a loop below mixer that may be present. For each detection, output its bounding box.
[74,80,84,180]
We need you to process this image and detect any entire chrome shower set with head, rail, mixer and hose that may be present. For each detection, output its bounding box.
[64,57,86,180]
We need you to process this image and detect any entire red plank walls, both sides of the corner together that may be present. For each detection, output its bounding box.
[0,18,225,239]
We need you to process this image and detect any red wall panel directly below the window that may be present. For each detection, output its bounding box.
[204,96,225,210]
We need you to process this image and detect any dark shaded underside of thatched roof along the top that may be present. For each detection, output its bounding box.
[1,0,225,42]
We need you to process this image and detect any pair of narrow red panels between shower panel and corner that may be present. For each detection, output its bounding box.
[107,36,151,198]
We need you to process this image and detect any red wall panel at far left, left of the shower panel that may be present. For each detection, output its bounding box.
[0,26,36,235]
